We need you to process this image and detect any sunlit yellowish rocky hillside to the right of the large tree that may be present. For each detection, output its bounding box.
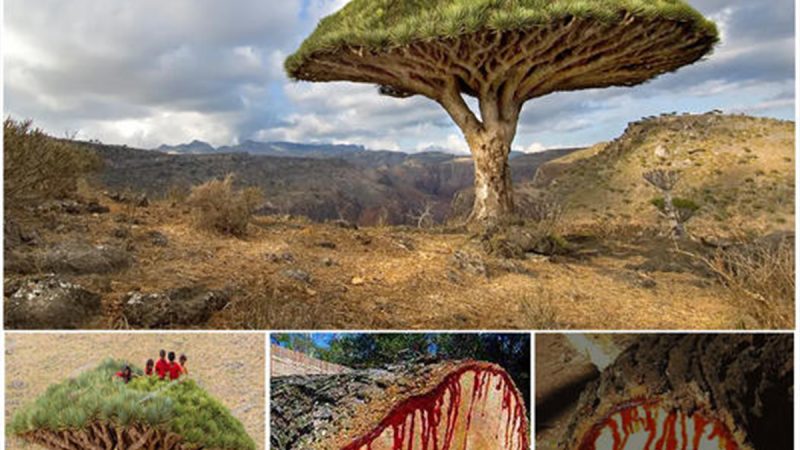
[519,113,795,235]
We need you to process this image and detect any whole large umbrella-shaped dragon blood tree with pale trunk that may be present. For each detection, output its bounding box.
[286,0,718,224]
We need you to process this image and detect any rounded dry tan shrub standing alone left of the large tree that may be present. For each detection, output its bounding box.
[187,175,264,237]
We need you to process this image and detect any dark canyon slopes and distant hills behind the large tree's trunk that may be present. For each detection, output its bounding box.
[87,141,572,225]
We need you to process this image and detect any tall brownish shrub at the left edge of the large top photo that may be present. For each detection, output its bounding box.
[3,117,102,208]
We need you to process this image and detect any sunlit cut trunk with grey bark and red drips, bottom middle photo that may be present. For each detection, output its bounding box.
[270,361,529,450]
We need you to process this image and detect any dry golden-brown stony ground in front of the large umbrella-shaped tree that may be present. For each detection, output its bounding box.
[6,199,768,330]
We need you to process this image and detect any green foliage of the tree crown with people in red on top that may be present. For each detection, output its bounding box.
[8,359,255,449]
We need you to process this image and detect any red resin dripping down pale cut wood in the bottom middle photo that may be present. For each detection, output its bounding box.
[342,363,528,450]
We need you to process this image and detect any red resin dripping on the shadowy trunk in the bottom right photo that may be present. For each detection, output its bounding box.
[578,399,739,450]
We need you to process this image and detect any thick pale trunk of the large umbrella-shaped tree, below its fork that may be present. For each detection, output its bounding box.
[467,130,514,226]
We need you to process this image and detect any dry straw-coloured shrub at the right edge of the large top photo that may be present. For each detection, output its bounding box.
[708,236,795,329]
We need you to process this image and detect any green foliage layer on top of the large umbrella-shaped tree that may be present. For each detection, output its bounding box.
[286,0,718,75]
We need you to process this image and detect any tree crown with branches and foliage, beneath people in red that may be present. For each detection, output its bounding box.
[7,360,256,450]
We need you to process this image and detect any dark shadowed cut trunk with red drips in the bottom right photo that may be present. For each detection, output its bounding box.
[561,334,794,450]
